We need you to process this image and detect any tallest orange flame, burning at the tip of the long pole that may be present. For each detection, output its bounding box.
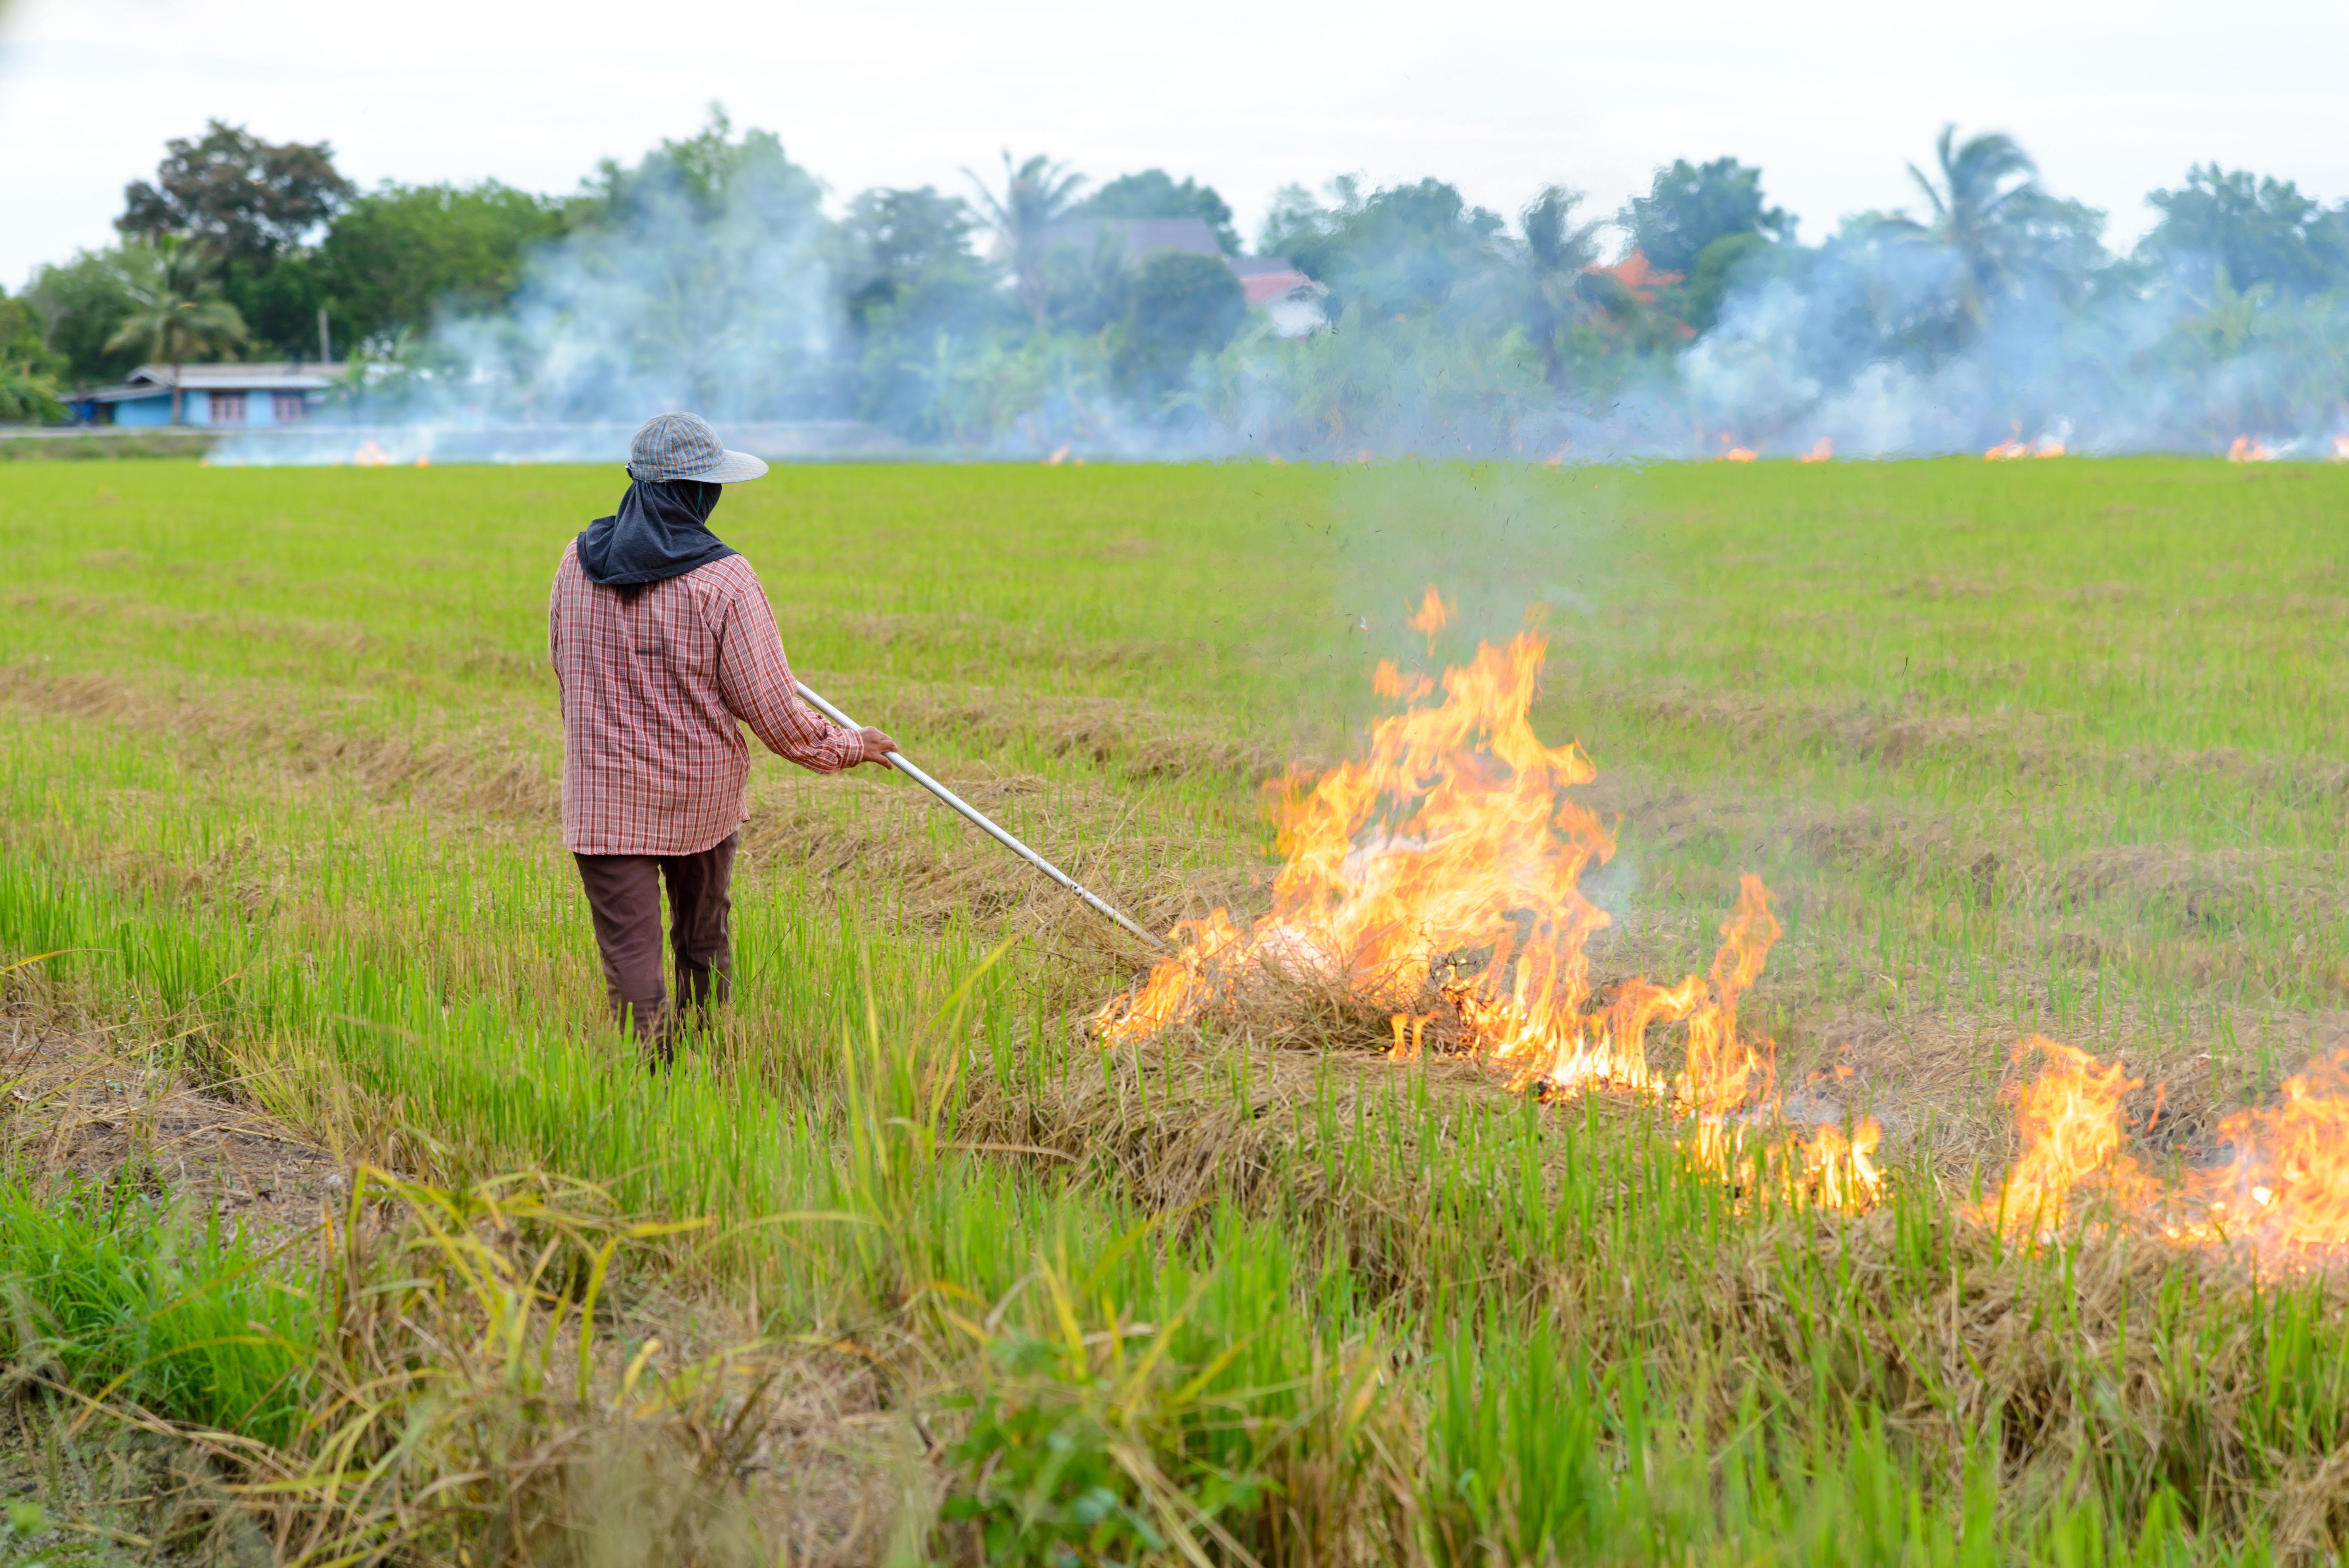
[1095,587,1882,1206]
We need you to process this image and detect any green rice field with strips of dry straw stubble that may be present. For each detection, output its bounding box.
[0,458,2349,1568]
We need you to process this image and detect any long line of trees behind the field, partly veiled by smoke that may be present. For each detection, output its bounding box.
[0,113,2349,451]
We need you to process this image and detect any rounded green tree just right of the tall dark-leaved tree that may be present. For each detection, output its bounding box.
[317,181,564,343]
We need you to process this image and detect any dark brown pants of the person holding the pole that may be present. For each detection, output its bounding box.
[571,833,737,1066]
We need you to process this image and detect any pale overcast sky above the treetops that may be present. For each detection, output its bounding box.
[0,0,2349,289]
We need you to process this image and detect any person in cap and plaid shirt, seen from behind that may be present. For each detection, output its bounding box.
[547,413,897,1066]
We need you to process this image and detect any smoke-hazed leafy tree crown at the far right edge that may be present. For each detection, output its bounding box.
[2140,164,2349,298]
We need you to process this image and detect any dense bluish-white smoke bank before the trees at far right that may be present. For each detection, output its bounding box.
[1663,244,2349,458]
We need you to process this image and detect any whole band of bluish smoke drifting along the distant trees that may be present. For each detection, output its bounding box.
[216,133,2349,463]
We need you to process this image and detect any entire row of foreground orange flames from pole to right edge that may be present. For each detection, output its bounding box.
[1095,582,2349,1265]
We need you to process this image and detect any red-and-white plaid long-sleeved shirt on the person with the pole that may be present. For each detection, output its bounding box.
[547,540,872,854]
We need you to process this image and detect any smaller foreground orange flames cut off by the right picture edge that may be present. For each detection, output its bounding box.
[1978,1040,2349,1268]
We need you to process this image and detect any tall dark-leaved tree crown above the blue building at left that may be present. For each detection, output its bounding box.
[115,120,350,275]
